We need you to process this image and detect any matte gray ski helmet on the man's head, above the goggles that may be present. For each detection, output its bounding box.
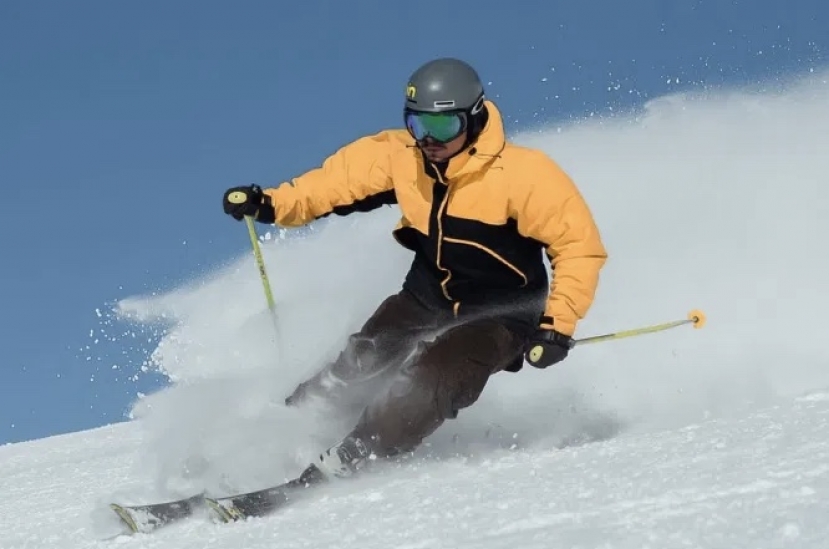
[406,58,484,115]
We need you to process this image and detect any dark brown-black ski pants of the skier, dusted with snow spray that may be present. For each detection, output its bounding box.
[286,290,526,457]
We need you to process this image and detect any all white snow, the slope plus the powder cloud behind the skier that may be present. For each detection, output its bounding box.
[0,70,829,549]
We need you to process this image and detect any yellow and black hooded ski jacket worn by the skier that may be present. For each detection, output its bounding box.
[264,101,607,335]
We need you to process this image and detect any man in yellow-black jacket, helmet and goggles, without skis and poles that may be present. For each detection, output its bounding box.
[223,58,607,481]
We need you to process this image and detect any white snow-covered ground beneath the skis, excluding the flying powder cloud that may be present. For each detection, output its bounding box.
[0,392,829,549]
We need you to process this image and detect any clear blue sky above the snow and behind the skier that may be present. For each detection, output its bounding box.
[0,0,829,443]
